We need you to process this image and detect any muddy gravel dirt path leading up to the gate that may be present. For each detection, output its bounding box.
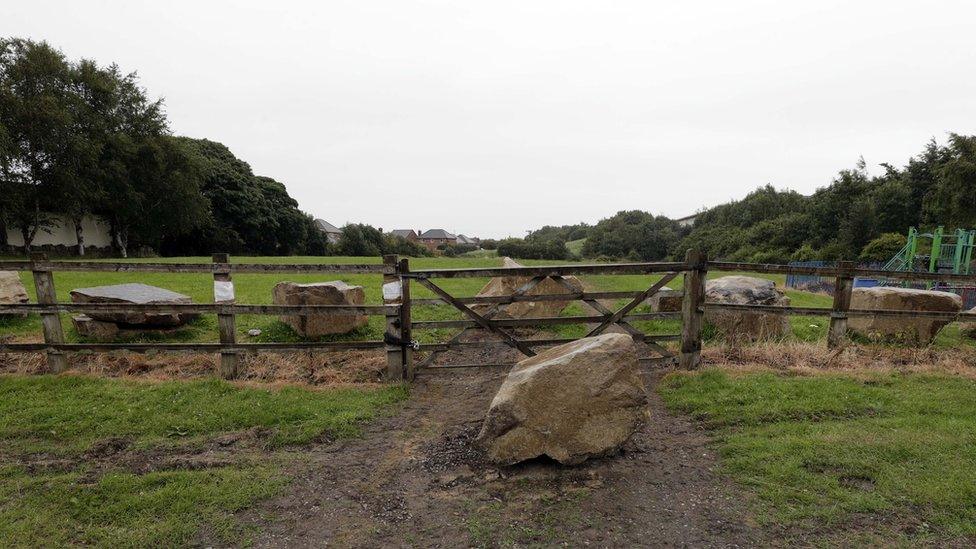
[231,369,759,547]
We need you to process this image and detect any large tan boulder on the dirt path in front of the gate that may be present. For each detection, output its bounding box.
[478,334,649,465]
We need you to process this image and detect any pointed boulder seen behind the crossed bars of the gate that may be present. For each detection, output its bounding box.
[471,257,583,318]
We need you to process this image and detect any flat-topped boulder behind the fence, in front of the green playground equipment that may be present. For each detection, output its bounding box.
[847,286,962,345]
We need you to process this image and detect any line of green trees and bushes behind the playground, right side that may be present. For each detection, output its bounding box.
[508,134,976,263]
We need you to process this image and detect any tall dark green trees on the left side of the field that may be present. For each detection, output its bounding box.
[0,38,330,257]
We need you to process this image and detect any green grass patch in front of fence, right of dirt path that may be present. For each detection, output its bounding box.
[659,369,976,542]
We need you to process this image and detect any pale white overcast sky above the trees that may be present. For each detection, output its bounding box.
[7,0,976,237]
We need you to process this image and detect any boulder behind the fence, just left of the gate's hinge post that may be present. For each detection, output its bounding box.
[273,280,369,337]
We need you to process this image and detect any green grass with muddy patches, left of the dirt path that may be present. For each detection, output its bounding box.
[0,376,406,547]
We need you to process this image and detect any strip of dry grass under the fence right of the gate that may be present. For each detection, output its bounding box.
[702,341,976,379]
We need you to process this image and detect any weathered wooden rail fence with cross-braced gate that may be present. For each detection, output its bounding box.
[0,251,976,380]
